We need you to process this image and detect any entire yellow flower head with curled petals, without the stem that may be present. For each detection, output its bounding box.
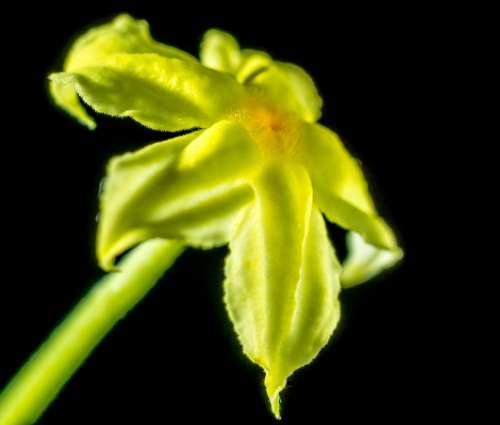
[50,15,402,417]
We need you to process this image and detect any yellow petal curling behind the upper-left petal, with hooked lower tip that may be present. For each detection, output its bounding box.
[50,14,196,129]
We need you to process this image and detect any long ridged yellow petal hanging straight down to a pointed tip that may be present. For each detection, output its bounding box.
[224,165,340,417]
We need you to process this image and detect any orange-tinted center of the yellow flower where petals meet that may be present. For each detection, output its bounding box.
[232,97,300,158]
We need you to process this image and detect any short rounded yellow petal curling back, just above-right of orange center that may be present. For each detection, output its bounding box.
[249,61,323,123]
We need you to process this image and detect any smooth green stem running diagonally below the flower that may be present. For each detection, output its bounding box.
[0,240,183,425]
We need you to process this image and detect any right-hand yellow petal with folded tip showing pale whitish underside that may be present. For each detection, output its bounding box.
[301,124,403,287]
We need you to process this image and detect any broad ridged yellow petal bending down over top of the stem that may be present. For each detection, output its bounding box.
[97,121,260,269]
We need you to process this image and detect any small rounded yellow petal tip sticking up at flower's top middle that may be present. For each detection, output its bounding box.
[200,29,242,74]
